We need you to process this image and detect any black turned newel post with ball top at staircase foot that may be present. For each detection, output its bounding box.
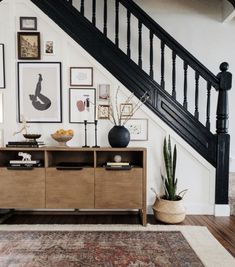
[215,62,232,205]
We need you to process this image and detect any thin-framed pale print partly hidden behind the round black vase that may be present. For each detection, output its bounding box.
[125,119,148,141]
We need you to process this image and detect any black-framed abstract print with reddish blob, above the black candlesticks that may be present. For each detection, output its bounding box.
[69,88,96,123]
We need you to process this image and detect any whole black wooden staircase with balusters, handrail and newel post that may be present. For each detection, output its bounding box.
[31,0,231,207]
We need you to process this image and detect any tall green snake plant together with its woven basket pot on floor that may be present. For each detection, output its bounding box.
[152,136,187,223]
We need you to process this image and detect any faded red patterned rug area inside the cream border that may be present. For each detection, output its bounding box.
[0,231,204,267]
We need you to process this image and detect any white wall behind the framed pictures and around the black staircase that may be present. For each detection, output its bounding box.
[0,0,228,214]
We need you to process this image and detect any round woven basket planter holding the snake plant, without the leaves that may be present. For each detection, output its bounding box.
[152,198,185,224]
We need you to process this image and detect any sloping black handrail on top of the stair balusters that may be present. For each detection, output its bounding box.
[119,0,219,89]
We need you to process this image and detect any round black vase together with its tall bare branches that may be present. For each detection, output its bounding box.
[108,87,149,147]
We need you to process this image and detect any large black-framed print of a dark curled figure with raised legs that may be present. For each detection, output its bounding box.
[18,62,62,122]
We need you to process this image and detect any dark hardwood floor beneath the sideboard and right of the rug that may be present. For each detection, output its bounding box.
[0,212,235,257]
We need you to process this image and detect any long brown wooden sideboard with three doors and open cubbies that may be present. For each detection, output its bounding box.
[0,147,147,225]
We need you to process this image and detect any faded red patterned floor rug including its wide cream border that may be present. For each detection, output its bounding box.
[0,225,235,267]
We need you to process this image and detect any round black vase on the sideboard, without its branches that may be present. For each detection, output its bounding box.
[108,125,130,147]
